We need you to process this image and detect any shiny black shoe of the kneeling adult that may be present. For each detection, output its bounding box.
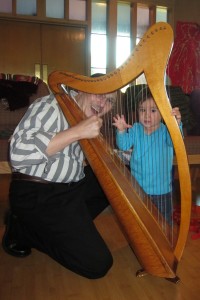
[2,212,31,257]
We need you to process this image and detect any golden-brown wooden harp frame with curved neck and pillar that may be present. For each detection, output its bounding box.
[48,22,191,280]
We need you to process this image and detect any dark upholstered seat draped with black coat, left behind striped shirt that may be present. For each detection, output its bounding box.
[0,73,50,173]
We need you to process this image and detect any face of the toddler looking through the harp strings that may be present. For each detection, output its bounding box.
[138,98,162,134]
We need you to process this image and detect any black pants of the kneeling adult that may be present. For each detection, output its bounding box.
[10,167,113,278]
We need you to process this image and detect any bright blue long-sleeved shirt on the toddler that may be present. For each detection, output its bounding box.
[116,123,182,195]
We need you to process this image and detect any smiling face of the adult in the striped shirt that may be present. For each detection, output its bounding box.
[76,92,117,117]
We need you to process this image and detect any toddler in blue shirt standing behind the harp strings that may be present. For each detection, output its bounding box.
[113,88,182,223]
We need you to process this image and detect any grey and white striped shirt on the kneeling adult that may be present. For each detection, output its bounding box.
[10,94,84,183]
